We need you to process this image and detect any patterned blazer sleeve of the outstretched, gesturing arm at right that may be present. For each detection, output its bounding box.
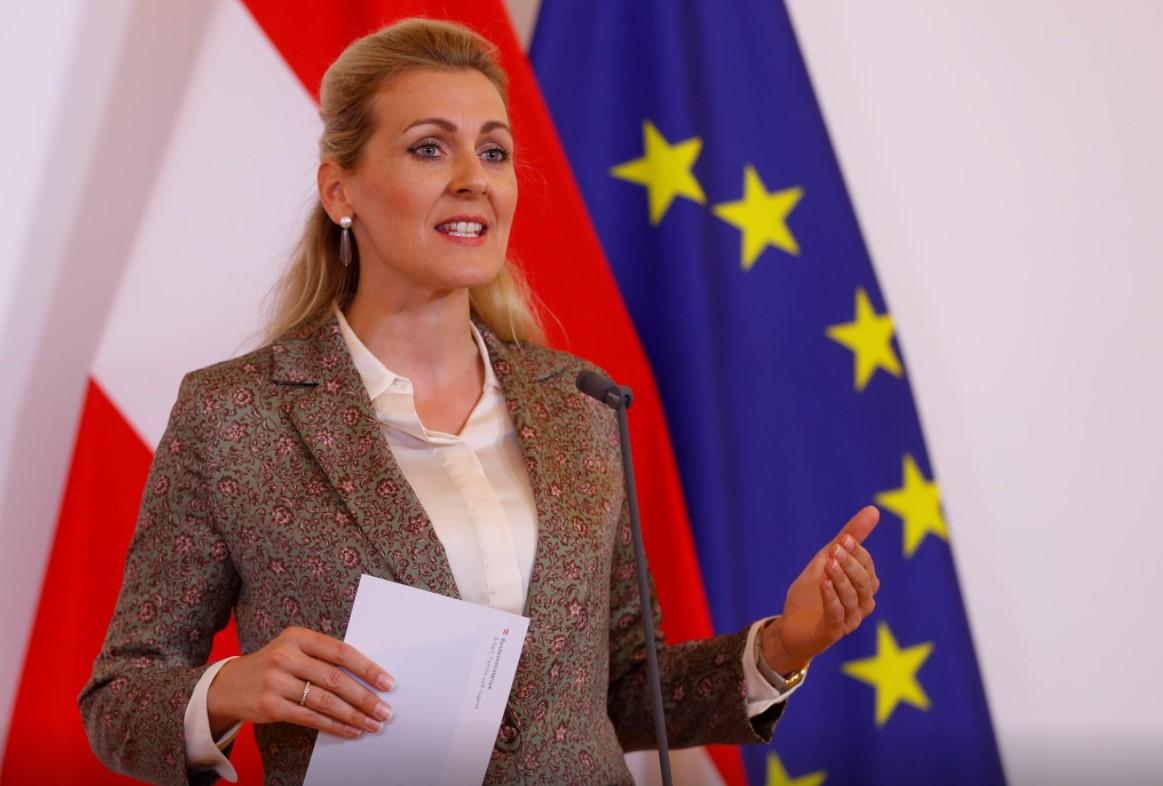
[607,501,787,751]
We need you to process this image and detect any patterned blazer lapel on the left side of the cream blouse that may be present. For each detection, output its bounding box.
[272,317,459,598]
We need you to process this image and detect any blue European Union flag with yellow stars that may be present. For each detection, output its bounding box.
[531,0,1004,785]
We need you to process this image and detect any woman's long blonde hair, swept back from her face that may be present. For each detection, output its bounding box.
[266,19,544,343]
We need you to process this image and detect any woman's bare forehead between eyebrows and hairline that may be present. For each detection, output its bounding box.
[373,69,508,133]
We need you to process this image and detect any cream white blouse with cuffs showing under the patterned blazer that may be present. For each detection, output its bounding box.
[185,310,802,783]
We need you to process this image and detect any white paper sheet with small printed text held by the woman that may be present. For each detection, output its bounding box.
[304,576,529,786]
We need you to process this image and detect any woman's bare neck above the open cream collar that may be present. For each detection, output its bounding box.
[343,287,479,385]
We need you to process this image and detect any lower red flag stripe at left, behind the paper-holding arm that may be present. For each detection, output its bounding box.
[0,380,262,786]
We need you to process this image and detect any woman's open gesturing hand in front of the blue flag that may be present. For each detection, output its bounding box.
[762,505,880,674]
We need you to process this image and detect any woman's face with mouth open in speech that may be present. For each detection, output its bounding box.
[343,70,516,296]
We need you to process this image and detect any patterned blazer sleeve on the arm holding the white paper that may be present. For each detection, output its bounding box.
[79,374,240,785]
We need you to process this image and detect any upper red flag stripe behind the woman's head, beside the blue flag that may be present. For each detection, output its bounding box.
[244,0,747,786]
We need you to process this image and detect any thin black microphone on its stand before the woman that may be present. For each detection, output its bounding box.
[575,370,671,786]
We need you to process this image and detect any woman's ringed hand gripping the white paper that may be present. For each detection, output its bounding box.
[206,628,395,739]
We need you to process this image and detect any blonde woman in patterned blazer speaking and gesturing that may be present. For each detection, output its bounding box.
[80,20,878,784]
